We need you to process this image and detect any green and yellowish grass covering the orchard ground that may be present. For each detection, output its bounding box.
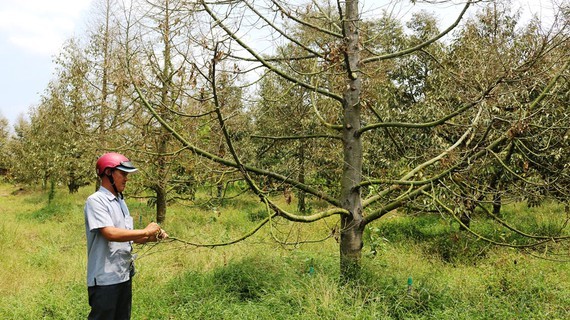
[0,184,570,319]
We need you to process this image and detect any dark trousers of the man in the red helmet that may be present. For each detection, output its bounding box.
[87,280,133,320]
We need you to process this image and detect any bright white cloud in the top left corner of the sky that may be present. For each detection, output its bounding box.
[0,0,92,55]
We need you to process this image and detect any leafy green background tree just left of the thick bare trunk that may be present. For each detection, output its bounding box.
[253,44,340,212]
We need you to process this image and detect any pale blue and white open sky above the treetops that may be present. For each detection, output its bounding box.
[0,0,556,129]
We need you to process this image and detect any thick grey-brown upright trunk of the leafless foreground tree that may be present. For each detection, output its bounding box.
[340,1,364,282]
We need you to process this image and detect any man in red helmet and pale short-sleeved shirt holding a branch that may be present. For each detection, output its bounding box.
[84,152,168,319]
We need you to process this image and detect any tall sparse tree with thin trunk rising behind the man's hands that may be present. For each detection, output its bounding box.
[123,0,211,222]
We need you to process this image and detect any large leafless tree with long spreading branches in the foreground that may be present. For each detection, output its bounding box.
[129,0,568,280]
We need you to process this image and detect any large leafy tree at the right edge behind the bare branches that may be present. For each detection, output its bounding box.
[420,3,567,227]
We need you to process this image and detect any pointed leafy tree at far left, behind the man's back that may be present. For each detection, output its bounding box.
[6,39,94,192]
